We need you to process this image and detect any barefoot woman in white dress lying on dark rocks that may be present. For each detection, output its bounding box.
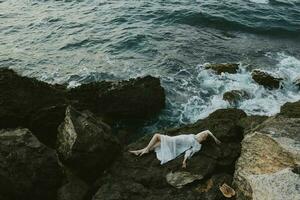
[129,130,221,168]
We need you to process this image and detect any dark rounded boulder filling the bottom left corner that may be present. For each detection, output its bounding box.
[0,129,62,200]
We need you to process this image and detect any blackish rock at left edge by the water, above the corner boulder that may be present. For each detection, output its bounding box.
[0,68,66,146]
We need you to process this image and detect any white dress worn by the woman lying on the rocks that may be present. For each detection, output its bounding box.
[155,134,201,164]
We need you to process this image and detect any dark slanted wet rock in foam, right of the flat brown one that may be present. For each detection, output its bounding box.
[251,69,283,89]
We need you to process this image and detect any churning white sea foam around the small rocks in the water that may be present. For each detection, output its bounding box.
[160,53,300,130]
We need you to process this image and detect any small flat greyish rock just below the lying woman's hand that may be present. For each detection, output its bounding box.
[166,172,203,189]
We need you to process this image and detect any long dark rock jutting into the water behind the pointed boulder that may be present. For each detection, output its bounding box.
[68,76,165,119]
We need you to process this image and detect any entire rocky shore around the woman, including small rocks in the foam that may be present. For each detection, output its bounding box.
[0,68,300,200]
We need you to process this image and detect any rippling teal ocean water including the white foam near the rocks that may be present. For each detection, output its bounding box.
[0,0,300,132]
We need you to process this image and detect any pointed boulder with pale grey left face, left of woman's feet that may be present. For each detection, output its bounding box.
[57,106,120,181]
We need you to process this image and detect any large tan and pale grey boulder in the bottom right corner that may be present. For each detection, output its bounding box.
[234,115,300,200]
